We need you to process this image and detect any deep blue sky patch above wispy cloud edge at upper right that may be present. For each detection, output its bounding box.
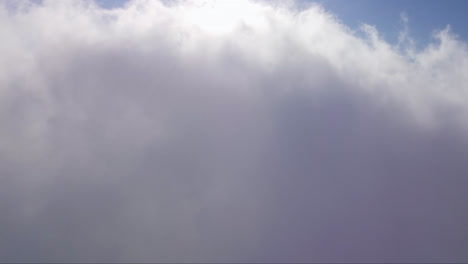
[317,0,468,45]
